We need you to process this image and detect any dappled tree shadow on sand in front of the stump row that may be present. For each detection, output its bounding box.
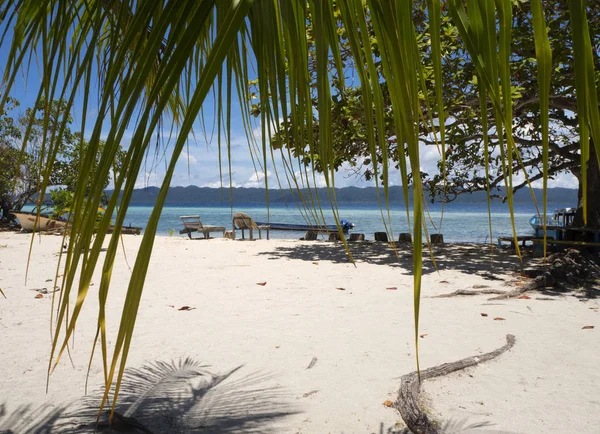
[259,241,520,279]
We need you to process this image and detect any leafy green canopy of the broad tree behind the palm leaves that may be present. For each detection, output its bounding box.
[271,0,600,225]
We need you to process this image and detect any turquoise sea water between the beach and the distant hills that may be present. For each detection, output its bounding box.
[109,204,535,243]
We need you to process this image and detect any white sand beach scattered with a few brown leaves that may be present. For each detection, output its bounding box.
[0,233,600,433]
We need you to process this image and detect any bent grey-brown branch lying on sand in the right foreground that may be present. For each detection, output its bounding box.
[396,335,515,434]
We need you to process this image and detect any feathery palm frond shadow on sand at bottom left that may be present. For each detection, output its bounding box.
[0,358,298,434]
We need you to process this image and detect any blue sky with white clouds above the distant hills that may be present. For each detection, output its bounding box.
[0,30,578,192]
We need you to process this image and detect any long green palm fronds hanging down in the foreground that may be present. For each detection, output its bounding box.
[0,0,600,420]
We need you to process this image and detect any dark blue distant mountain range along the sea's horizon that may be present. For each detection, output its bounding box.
[109,185,577,207]
